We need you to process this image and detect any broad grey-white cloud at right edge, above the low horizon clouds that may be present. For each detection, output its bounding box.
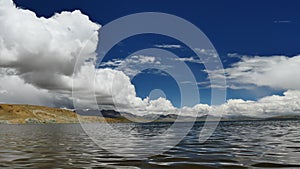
[210,55,300,90]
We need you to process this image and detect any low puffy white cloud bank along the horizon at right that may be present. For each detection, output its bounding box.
[144,90,300,117]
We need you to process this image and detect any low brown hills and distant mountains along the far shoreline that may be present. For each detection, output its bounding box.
[0,104,300,124]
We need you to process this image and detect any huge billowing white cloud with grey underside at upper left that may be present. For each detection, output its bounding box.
[0,1,100,90]
